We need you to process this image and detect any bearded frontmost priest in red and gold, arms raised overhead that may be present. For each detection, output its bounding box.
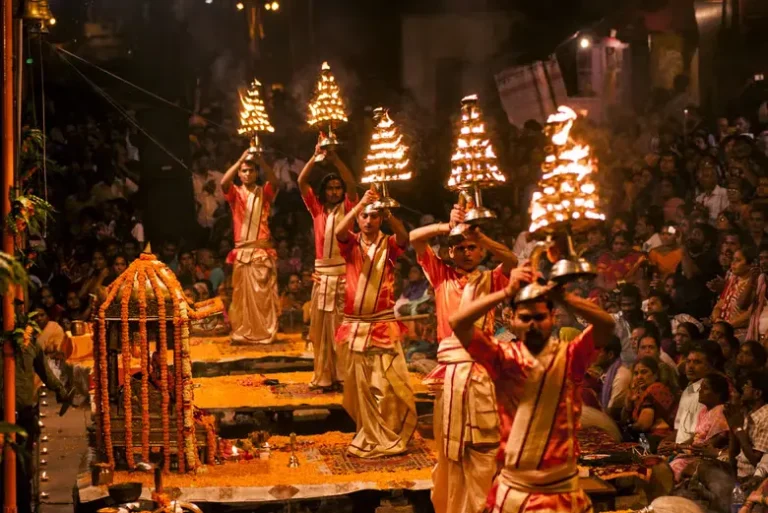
[451,267,614,513]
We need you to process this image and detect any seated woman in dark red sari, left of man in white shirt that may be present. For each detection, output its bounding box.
[621,356,675,440]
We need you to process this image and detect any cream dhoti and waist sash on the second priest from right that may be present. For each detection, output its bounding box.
[424,336,500,513]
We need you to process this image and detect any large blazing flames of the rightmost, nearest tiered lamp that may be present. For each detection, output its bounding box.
[529,106,605,233]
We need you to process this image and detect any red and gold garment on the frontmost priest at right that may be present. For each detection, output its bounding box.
[468,326,594,513]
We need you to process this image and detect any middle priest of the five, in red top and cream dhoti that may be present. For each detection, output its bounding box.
[335,189,416,458]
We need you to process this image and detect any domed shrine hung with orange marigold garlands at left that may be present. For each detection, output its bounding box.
[94,246,223,472]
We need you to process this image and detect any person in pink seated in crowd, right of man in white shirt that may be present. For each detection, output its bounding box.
[669,373,730,482]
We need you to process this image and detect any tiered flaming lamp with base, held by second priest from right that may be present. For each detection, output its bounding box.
[448,94,506,242]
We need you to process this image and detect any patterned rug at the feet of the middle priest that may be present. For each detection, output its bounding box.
[318,438,437,475]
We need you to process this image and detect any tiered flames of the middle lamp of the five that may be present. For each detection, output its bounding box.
[360,108,412,183]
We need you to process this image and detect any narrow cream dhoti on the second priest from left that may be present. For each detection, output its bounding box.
[309,257,347,387]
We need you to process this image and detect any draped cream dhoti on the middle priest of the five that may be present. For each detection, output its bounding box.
[343,310,416,458]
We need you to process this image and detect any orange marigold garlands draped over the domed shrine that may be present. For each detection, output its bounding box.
[94,253,216,472]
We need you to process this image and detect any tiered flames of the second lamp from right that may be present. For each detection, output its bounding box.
[448,94,506,189]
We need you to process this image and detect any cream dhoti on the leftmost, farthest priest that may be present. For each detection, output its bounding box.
[229,243,280,344]
